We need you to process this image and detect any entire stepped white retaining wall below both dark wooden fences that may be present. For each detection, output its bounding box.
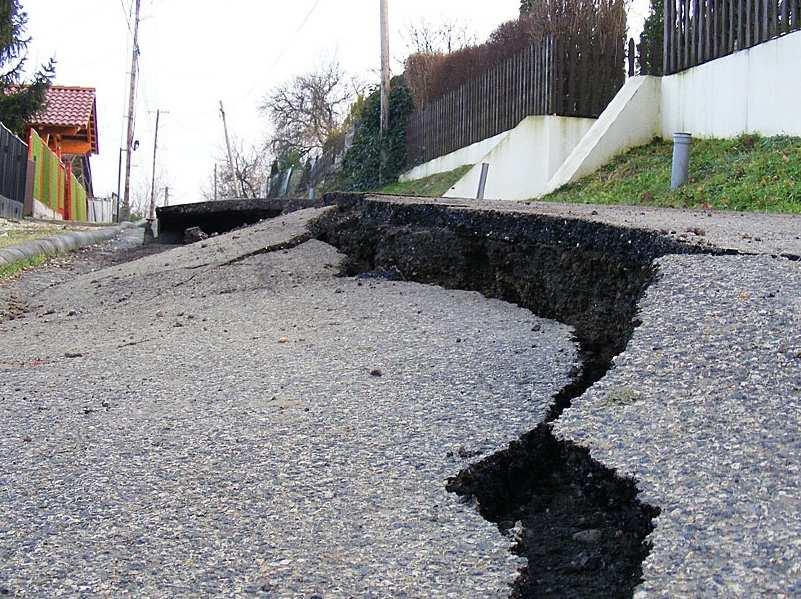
[401,32,801,200]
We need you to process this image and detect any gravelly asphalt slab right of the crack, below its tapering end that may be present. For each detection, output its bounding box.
[555,256,801,597]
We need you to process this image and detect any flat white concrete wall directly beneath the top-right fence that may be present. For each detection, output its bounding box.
[661,32,801,139]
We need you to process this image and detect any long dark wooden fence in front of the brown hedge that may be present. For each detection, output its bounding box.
[406,37,625,165]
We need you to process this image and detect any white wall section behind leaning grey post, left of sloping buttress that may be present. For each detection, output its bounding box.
[445,116,595,200]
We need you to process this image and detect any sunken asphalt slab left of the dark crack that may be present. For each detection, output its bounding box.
[0,210,577,597]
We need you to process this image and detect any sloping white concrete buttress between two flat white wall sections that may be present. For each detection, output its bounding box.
[542,77,660,195]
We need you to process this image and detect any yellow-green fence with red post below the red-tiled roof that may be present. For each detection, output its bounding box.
[28,129,88,221]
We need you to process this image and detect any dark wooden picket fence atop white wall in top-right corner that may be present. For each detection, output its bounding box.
[664,0,801,75]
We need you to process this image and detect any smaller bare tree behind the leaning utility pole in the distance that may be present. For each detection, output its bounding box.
[201,139,272,202]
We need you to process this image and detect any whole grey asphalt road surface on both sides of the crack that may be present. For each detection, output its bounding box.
[0,199,801,598]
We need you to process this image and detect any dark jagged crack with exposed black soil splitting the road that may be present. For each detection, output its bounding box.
[314,194,716,597]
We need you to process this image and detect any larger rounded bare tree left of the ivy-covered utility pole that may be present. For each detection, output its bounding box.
[261,60,364,158]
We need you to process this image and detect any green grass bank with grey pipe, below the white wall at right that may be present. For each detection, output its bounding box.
[543,135,801,214]
